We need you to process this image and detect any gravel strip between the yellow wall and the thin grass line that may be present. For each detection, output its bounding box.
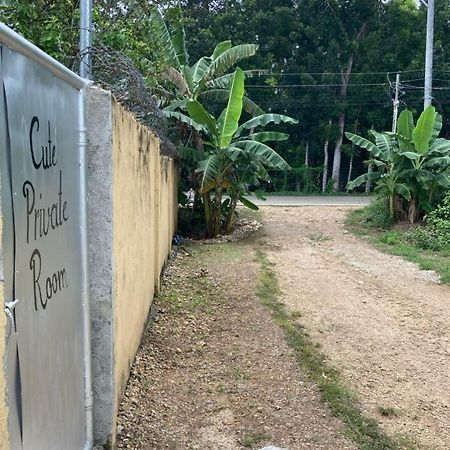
[117,241,355,450]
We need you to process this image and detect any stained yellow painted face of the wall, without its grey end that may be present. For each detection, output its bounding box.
[112,100,177,422]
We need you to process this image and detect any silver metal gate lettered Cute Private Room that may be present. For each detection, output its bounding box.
[0,25,92,450]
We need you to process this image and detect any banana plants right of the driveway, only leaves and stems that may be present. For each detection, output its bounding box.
[346,106,450,222]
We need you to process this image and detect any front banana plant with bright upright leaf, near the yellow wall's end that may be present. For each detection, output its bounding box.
[181,68,297,236]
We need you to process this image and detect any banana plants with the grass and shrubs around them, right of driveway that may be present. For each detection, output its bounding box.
[346,106,450,283]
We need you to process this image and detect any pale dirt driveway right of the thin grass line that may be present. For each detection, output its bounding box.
[262,206,450,449]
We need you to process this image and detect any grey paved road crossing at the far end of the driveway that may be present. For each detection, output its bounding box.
[250,195,371,206]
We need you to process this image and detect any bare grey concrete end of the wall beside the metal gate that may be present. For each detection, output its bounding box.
[86,89,115,443]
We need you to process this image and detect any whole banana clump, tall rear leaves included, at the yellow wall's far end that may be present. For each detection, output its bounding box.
[152,9,298,237]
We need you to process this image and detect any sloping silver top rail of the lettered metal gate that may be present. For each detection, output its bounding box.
[0,22,91,89]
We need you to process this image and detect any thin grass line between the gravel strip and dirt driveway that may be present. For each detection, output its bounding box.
[256,250,417,450]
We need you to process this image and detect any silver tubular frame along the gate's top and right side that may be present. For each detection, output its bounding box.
[0,22,93,450]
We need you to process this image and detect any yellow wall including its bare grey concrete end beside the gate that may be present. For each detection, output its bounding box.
[87,88,177,446]
